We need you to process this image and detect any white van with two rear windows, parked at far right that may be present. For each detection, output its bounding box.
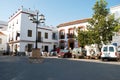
[101,45,119,60]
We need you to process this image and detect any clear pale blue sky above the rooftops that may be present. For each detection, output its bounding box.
[0,0,120,26]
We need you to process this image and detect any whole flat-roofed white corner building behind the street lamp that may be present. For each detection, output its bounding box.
[8,7,58,53]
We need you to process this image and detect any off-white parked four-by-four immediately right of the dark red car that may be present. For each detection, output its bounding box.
[72,47,85,58]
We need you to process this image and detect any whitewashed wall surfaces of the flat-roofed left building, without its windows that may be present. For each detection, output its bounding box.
[7,7,57,52]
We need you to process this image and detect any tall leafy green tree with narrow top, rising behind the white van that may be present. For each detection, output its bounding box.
[88,0,116,44]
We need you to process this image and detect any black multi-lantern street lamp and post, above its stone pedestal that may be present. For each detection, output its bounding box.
[29,11,45,49]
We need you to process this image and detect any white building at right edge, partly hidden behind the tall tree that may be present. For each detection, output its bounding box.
[110,5,120,46]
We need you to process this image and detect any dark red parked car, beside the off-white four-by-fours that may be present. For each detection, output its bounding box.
[58,49,72,58]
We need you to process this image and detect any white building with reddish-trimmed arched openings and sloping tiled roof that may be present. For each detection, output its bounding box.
[58,19,89,49]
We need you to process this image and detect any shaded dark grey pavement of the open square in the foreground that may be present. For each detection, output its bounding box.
[0,56,120,80]
